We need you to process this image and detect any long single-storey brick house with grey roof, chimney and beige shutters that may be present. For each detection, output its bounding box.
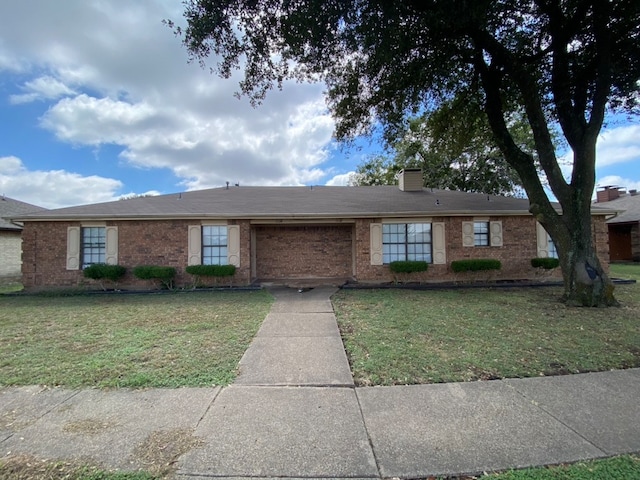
[12,169,612,288]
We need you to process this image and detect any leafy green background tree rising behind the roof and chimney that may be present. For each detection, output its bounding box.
[352,95,535,196]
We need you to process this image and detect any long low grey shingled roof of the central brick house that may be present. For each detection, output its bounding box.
[16,186,614,221]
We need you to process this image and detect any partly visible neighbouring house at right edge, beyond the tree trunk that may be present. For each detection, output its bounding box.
[596,186,640,262]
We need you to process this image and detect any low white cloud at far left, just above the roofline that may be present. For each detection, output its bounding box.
[0,157,122,208]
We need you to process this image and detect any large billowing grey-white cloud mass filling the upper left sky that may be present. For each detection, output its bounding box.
[0,0,334,197]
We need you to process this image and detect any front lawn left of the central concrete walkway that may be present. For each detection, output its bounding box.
[0,291,272,388]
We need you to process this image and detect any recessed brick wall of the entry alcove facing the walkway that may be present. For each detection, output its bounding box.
[254,225,353,279]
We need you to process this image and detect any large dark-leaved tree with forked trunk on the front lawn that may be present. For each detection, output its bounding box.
[176,0,640,305]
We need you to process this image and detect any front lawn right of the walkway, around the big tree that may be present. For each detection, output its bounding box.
[332,267,640,386]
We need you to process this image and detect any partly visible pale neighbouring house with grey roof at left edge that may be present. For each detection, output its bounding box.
[0,196,43,283]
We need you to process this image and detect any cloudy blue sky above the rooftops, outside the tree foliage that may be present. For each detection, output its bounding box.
[0,0,640,208]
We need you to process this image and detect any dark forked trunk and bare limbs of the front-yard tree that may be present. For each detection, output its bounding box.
[476,38,617,307]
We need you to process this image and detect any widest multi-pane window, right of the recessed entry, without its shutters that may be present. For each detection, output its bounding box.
[382,223,431,264]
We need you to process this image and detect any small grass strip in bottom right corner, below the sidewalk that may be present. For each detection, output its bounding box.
[483,455,640,480]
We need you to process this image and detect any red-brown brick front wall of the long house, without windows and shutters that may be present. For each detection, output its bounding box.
[22,215,609,289]
